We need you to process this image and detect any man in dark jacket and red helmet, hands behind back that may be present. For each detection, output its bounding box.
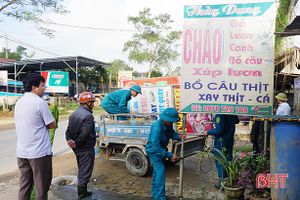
[66,92,96,199]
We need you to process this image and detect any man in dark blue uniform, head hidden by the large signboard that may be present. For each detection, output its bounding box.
[204,114,239,189]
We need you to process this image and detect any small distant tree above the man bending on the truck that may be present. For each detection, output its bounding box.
[106,59,133,85]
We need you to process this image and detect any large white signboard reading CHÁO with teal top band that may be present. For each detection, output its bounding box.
[180,0,276,115]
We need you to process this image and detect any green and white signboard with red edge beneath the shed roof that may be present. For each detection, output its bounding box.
[41,71,69,94]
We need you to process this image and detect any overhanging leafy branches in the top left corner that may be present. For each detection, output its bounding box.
[0,0,68,37]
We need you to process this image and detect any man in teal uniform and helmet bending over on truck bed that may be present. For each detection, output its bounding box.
[101,85,142,120]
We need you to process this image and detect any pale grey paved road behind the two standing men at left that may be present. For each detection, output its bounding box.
[0,121,71,175]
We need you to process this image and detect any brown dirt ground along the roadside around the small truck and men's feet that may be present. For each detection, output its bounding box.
[0,150,222,199]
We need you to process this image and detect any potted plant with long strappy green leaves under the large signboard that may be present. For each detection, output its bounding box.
[213,149,245,199]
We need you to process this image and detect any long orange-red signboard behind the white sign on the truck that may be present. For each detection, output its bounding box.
[123,76,180,88]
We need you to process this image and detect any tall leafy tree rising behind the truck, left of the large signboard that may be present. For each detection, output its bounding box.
[123,8,181,77]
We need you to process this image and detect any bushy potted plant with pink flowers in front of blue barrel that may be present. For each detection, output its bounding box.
[239,153,271,200]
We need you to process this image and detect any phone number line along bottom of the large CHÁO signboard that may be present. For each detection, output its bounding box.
[192,105,248,113]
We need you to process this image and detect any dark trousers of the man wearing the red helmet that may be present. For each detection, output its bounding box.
[75,149,95,186]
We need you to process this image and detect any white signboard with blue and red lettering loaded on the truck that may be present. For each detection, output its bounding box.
[130,86,174,113]
